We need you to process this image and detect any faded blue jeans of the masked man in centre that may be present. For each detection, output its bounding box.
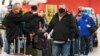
[52,41,71,56]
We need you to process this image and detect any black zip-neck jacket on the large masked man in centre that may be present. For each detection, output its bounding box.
[47,13,76,41]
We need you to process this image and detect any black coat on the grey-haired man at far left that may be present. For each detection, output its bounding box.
[4,11,24,42]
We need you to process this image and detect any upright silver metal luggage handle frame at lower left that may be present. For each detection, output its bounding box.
[9,35,32,56]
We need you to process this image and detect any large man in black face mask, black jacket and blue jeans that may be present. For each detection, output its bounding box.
[44,4,75,56]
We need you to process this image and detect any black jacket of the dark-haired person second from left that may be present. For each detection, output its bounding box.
[25,12,44,33]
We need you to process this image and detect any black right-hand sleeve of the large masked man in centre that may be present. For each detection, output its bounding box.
[69,15,79,40]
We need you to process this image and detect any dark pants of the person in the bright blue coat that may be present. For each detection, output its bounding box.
[81,36,90,55]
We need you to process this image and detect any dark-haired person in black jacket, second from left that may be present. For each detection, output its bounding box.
[25,5,44,47]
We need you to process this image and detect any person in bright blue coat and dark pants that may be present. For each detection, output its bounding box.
[78,14,95,56]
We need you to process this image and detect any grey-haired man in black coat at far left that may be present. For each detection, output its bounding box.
[3,3,25,53]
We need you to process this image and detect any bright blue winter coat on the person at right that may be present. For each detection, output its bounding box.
[78,14,95,36]
